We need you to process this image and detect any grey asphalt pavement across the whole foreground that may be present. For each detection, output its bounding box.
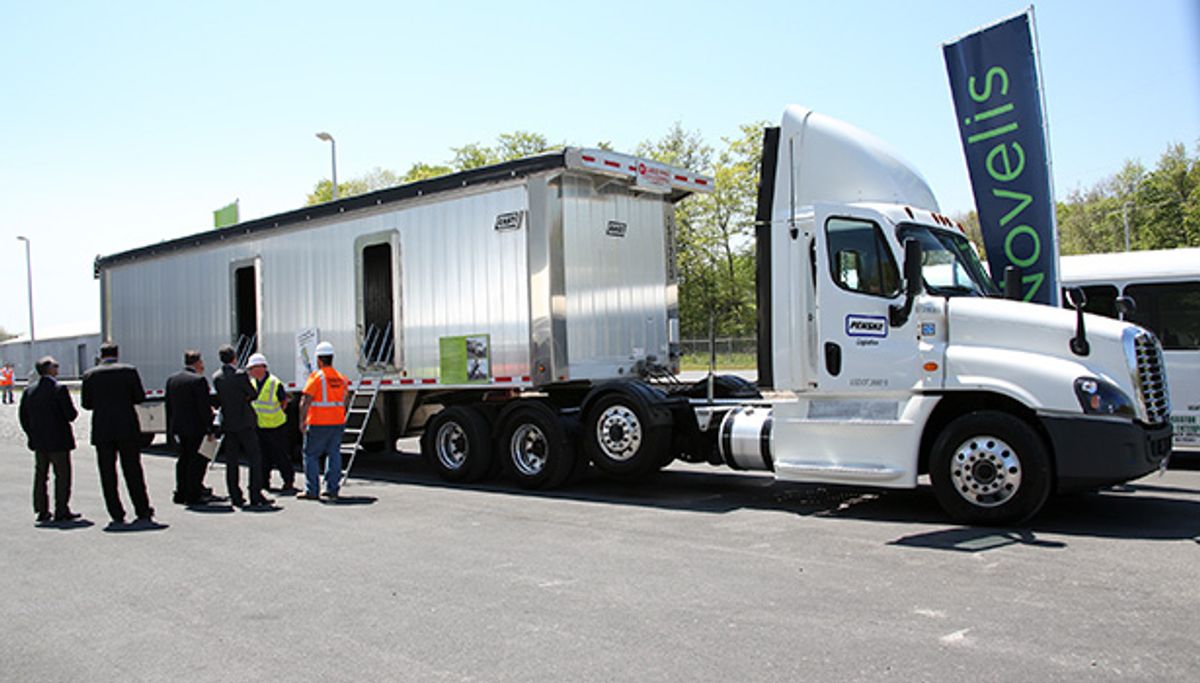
[0,396,1200,682]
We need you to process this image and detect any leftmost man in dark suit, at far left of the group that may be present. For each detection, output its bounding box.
[19,355,79,522]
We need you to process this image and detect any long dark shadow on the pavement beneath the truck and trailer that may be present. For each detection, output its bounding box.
[343,453,1200,544]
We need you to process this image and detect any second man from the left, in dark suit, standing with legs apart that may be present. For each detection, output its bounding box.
[80,342,154,525]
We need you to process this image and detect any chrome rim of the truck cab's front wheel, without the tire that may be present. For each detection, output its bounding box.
[950,435,1021,508]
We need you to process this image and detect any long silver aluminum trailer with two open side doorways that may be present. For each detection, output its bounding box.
[95,148,712,478]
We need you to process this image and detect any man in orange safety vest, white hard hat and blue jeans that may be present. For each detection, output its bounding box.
[296,342,350,501]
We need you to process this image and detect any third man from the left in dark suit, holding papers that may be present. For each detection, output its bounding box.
[167,351,212,505]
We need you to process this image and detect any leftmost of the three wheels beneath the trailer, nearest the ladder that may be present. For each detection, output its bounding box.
[421,406,492,481]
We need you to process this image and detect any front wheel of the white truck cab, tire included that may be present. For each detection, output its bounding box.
[929,411,1051,526]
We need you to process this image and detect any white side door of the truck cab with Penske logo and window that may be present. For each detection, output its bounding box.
[814,205,922,395]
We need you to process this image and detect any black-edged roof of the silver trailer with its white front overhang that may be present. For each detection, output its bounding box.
[92,148,713,271]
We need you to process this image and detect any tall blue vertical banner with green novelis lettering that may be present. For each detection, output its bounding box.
[942,7,1058,306]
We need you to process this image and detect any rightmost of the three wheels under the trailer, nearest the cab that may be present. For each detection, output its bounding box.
[582,393,671,479]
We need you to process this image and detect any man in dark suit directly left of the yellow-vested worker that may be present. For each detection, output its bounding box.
[212,345,272,508]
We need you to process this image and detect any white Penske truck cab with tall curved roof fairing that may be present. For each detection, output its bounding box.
[739,107,1171,523]
